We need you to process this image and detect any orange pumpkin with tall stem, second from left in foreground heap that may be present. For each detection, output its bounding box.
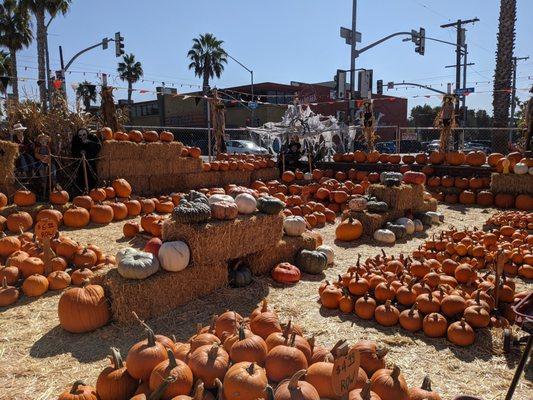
[96,347,139,400]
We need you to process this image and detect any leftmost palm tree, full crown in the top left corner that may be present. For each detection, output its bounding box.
[0,0,33,101]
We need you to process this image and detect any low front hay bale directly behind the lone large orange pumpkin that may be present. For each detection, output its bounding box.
[91,262,228,324]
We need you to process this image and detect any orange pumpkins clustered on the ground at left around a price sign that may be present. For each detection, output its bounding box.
[0,232,115,306]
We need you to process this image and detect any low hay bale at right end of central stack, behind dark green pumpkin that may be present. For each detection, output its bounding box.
[244,233,317,275]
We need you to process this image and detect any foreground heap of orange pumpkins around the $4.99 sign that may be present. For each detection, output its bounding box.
[59,302,440,400]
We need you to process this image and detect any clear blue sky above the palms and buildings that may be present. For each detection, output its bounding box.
[12,0,533,112]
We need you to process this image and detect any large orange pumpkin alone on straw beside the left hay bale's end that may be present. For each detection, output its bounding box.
[57,284,111,333]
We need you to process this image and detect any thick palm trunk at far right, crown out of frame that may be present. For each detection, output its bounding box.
[492,0,516,152]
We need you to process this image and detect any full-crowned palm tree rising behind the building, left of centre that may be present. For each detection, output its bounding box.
[187,33,228,93]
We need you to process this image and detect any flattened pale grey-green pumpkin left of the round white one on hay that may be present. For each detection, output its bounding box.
[116,248,159,279]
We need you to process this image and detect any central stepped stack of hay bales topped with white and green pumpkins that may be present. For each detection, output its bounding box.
[92,213,317,323]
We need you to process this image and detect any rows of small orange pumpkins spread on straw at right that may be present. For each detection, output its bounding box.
[319,226,533,346]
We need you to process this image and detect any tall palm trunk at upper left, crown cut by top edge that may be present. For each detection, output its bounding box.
[22,0,72,109]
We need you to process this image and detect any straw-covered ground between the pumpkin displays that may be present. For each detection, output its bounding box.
[0,206,533,400]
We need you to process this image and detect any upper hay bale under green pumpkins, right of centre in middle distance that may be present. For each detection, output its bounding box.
[368,184,424,210]
